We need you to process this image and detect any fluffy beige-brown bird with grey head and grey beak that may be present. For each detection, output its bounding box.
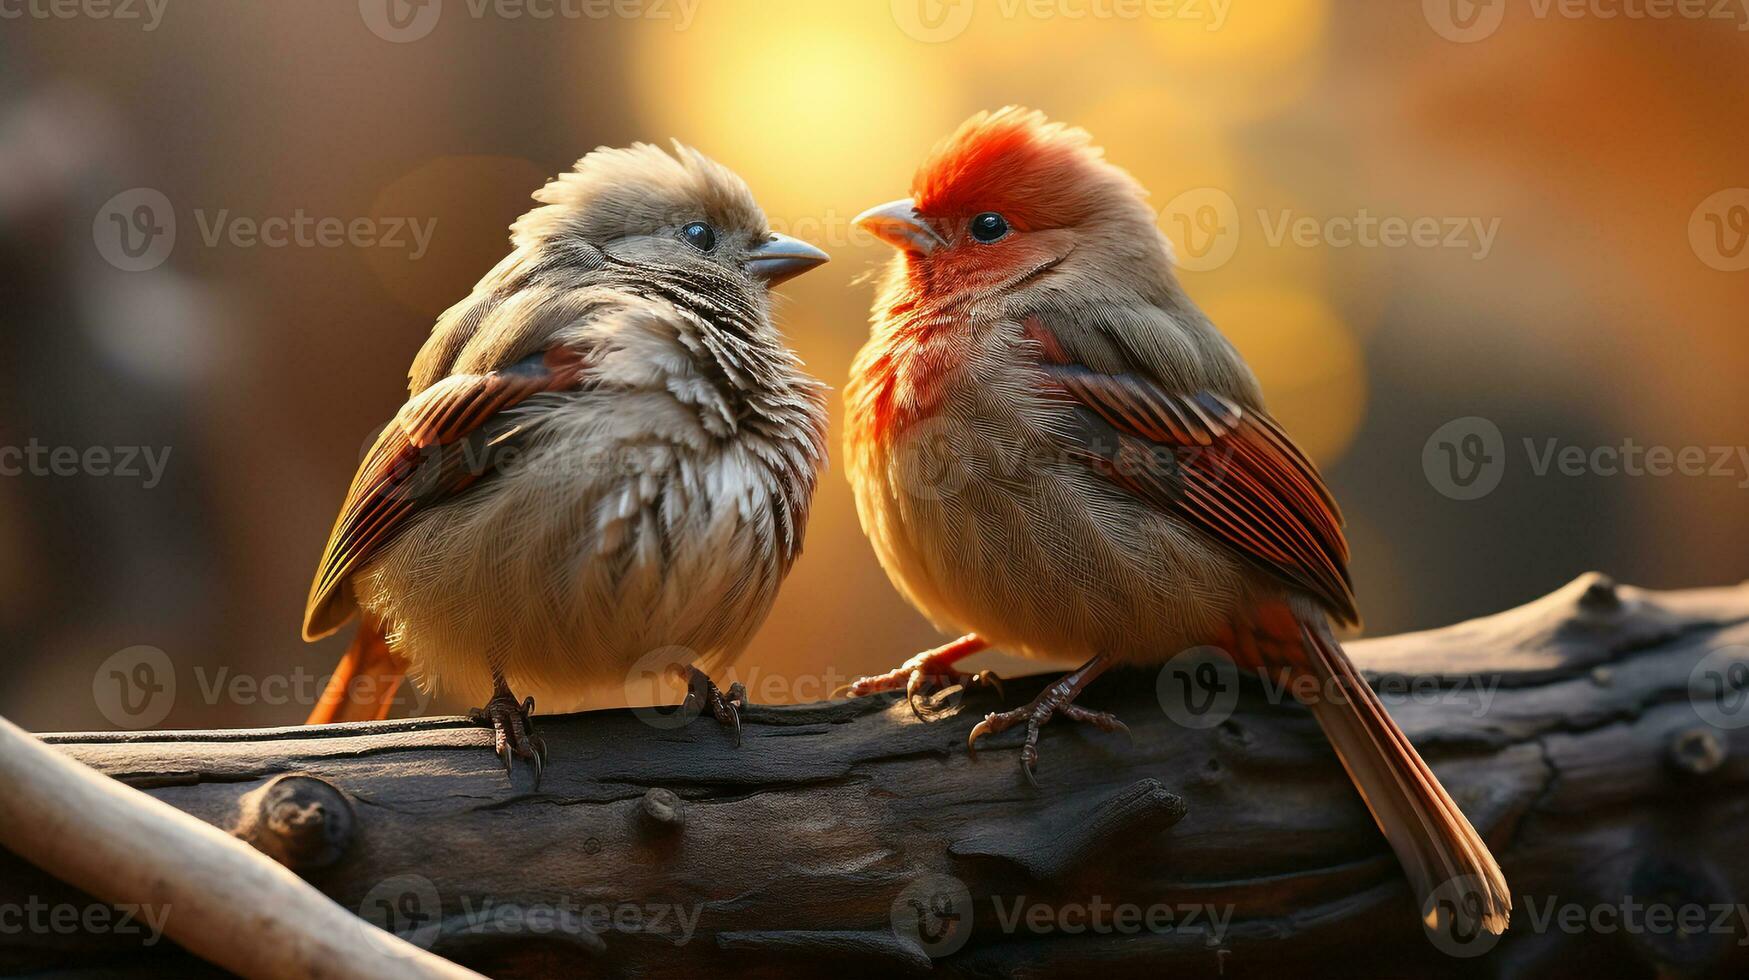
[303,142,827,786]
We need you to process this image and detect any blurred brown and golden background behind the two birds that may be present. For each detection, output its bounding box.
[0,0,1749,730]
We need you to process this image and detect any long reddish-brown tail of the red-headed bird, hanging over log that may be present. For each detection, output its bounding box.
[1294,623,1513,936]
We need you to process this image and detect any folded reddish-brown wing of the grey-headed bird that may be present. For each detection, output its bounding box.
[304,345,586,639]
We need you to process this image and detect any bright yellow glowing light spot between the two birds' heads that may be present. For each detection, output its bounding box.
[633,0,964,221]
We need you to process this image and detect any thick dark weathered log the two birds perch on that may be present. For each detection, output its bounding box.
[0,576,1749,980]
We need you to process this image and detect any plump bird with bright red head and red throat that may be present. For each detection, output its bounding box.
[843,107,1511,933]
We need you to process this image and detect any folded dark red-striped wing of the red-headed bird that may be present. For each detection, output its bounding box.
[1027,309,1359,623]
